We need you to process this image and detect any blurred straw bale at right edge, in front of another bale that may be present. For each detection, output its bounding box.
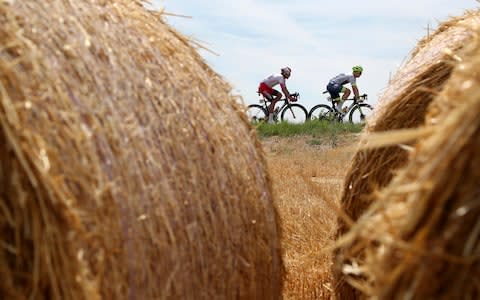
[336,18,480,299]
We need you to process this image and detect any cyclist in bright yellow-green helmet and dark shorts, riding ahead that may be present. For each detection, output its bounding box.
[327,66,363,113]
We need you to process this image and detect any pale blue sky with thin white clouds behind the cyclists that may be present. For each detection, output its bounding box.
[152,0,479,109]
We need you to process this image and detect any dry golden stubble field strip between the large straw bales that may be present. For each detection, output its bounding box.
[262,136,356,299]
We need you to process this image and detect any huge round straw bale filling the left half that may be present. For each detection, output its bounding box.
[0,0,282,299]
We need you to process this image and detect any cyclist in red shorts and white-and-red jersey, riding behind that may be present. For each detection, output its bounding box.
[258,67,297,123]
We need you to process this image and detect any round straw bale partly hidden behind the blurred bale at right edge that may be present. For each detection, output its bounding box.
[333,10,480,299]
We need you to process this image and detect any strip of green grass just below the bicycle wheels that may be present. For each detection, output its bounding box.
[257,120,364,138]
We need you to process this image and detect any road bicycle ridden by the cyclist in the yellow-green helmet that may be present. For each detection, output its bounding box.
[308,92,373,124]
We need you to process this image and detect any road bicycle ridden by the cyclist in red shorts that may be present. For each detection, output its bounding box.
[247,93,308,124]
